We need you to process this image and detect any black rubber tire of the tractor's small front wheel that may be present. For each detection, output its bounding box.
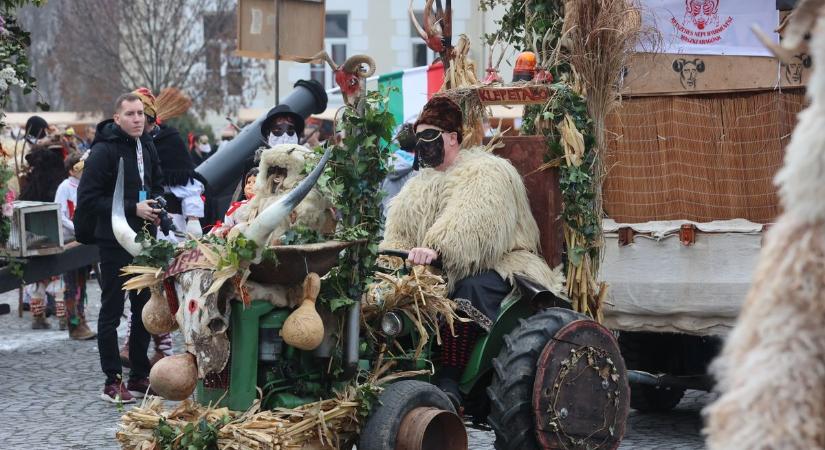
[358,380,455,450]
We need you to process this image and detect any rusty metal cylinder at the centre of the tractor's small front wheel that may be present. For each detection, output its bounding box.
[395,407,467,450]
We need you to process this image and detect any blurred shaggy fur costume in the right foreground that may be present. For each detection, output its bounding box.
[705,7,825,450]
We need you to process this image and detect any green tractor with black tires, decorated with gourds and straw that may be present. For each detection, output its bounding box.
[197,242,629,450]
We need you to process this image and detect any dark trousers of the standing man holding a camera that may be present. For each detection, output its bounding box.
[97,245,150,383]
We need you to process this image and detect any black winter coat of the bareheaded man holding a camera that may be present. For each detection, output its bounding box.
[77,119,163,246]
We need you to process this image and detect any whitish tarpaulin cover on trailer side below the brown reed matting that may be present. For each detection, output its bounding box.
[599,220,762,335]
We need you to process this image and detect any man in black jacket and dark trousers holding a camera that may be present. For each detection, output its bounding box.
[77,93,163,403]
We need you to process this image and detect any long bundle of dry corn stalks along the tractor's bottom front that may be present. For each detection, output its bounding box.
[116,389,360,450]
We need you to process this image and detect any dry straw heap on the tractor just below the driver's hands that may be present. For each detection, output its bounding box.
[361,266,464,358]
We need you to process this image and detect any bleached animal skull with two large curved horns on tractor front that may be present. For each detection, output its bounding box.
[112,148,331,381]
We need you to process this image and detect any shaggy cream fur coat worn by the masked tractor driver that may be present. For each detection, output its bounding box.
[381,148,564,293]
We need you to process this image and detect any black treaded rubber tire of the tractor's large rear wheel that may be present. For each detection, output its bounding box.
[487,308,588,450]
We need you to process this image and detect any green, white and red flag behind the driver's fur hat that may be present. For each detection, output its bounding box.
[378,61,444,125]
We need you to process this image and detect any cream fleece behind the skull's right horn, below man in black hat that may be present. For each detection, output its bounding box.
[235,144,335,243]
